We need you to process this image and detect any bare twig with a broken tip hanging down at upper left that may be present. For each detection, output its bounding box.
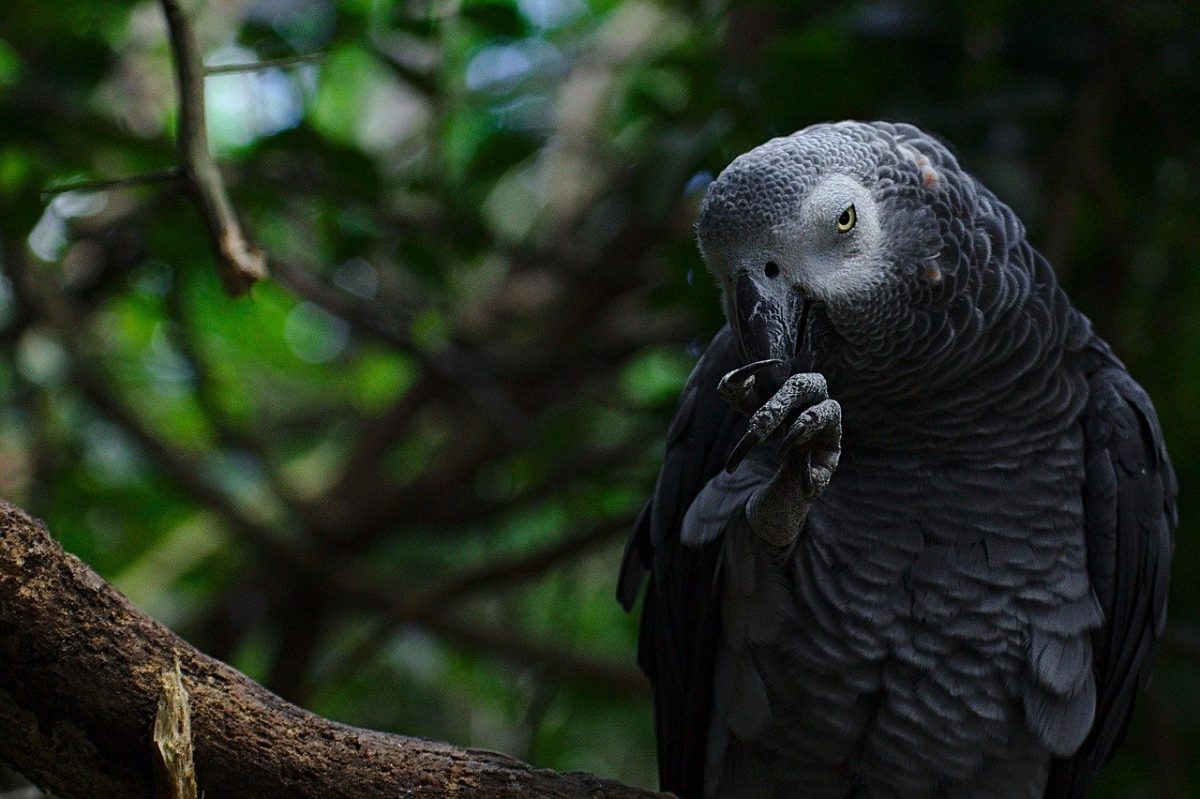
[162,0,266,296]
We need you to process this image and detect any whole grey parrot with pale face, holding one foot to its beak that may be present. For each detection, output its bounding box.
[618,122,1176,799]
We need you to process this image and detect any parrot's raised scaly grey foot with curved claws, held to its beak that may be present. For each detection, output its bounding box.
[718,361,841,547]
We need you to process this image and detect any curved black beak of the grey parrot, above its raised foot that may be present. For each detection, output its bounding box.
[731,270,808,374]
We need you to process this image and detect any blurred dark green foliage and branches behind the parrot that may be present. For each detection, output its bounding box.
[0,0,1200,797]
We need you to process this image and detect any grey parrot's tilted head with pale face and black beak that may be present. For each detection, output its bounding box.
[696,122,956,383]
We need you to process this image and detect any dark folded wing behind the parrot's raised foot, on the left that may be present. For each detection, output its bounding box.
[617,326,745,798]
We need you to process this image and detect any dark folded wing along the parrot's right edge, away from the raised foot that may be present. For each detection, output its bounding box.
[1046,359,1177,799]
